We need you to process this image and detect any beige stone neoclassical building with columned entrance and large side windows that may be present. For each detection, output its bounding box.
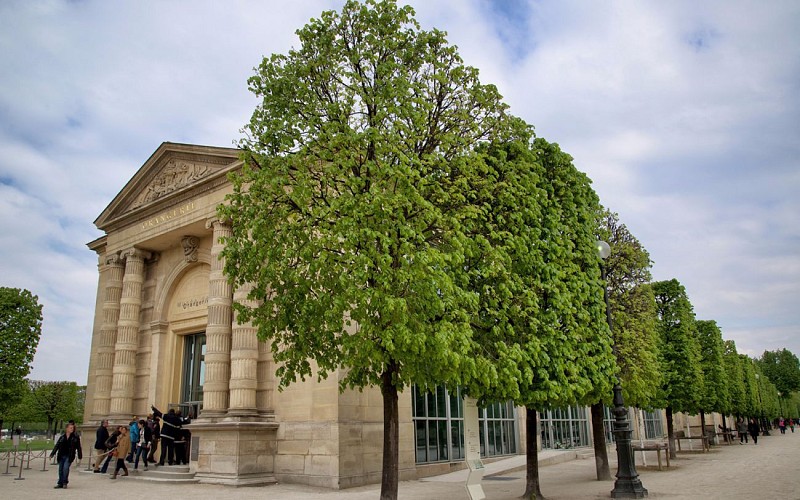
[84,143,704,488]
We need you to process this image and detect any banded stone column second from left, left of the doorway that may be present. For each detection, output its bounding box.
[110,248,150,420]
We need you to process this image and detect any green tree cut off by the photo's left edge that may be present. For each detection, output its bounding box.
[0,287,42,438]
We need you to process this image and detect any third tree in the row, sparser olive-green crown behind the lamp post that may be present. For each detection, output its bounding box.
[590,210,661,480]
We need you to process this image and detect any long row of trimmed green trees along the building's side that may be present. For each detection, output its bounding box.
[218,0,796,500]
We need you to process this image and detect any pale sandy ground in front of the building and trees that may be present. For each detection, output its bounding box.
[6,432,800,500]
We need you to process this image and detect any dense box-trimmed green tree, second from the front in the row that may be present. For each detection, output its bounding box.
[465,134,616,498]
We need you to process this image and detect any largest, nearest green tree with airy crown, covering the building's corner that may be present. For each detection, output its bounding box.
[219,0,510,499]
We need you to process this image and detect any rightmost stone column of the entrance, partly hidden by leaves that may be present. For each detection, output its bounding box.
[228,286,258,416]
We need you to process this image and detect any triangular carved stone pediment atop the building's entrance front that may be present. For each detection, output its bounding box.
[94,142,241,230]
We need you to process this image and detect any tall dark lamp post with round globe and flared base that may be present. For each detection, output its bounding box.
[597,241,647,498]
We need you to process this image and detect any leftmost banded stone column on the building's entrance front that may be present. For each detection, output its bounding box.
[92,253,125,419]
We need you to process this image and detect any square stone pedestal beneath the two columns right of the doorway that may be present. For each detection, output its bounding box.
[187,417,279,486]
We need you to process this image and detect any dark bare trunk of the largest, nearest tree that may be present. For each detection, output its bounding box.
[380,362,400,500]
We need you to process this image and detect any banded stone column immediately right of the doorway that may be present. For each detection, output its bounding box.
[201,219,233,418]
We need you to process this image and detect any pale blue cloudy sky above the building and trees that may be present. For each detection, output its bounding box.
[0,0,800,384]
